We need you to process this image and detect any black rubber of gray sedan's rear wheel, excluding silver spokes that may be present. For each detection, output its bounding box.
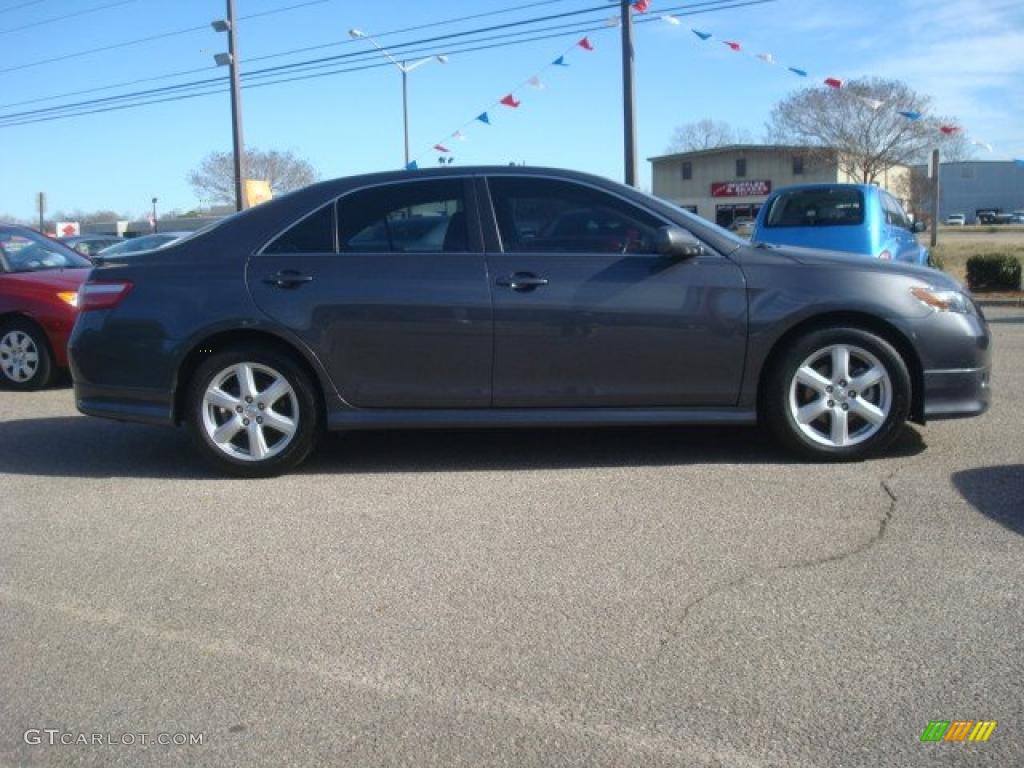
[185,344,323,477]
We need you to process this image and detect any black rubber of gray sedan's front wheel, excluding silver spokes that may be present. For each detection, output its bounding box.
[762,327,912,461]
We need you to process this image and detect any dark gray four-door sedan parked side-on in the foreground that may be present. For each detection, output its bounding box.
[71,166,989,477]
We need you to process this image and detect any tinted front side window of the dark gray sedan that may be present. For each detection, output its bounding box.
[487,176,663,254]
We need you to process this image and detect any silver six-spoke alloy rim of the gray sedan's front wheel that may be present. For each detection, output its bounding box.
[788,344,893,447]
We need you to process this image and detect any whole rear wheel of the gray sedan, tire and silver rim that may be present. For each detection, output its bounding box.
[185,344,323,477]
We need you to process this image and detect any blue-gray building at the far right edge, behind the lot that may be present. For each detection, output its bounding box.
[912,160,1024,224]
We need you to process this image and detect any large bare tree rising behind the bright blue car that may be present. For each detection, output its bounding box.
[768,78,971,183]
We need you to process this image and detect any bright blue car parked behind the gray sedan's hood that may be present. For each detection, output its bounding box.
[751,184,928,265]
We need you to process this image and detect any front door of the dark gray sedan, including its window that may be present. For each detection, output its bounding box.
[481,174,746,408]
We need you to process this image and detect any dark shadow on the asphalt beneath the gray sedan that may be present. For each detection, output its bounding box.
[0,417,925,480]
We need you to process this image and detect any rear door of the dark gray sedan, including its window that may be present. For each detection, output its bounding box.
[249,177,492,408]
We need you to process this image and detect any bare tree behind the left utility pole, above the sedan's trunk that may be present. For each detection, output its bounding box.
[187,147,319,203]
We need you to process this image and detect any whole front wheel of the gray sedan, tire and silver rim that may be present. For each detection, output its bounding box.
[763,328,911,461]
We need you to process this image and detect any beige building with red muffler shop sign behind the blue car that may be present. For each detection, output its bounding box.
[649,144,909,226]
